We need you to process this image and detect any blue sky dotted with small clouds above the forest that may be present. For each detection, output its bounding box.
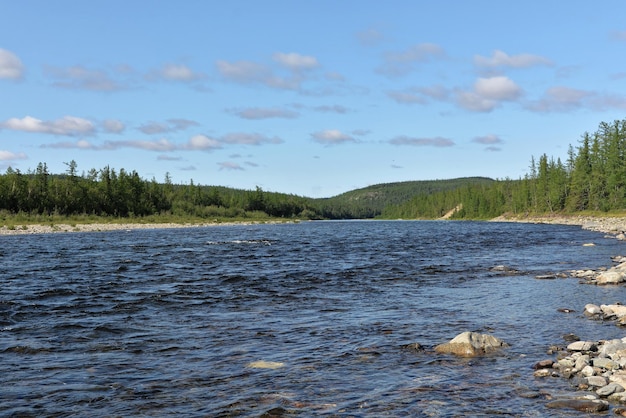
[0,0,626,197]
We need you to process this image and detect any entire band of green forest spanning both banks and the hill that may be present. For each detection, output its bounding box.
[0,116,626,221]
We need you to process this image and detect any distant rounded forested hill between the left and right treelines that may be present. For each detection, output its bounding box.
[314,177,495,219]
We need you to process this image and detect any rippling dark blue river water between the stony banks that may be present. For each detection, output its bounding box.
[0,221,626,417]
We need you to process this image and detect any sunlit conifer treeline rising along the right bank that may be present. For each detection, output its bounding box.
[382,120,626,219]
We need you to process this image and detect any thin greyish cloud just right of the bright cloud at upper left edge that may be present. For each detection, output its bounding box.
[44,65,129,92]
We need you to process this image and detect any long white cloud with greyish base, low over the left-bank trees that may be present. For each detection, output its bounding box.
[0,116,96,136]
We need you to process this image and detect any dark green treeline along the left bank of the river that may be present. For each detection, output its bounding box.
[0,161,318,218]
